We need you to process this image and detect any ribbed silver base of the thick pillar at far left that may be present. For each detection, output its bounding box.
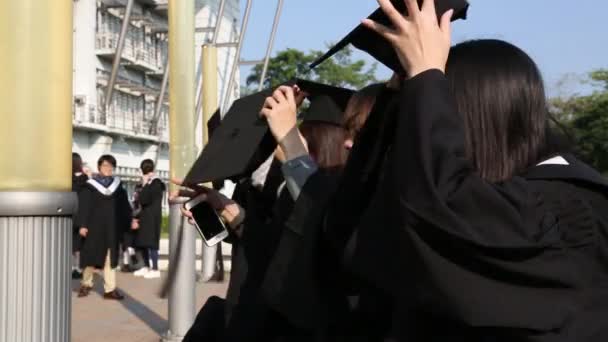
[0,192,76,342]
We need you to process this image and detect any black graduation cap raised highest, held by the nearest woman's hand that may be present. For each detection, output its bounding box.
[310,0,469,74]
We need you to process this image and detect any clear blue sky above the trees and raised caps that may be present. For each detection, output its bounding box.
[241,0,608,96]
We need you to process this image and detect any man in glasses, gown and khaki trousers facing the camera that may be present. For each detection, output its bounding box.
[76,155,131,300]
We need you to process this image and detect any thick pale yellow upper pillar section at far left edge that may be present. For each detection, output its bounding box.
[0,0,72,191]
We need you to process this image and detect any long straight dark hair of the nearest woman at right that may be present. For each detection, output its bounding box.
[446,40,548,182]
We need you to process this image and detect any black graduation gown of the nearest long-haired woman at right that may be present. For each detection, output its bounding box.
[266,71,608,342]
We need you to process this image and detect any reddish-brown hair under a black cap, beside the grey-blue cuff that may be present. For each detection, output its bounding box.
[299,121,348,169]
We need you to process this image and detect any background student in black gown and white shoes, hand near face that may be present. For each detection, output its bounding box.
[132,159,166,279]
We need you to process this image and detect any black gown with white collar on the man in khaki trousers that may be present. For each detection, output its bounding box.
[76,178,131,268]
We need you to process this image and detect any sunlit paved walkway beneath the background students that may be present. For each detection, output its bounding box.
[72,272,227,342]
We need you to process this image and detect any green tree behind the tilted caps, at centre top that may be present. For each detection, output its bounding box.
[246,47,377,89]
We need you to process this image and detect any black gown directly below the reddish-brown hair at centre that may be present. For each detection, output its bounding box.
[262,170,349,341]
